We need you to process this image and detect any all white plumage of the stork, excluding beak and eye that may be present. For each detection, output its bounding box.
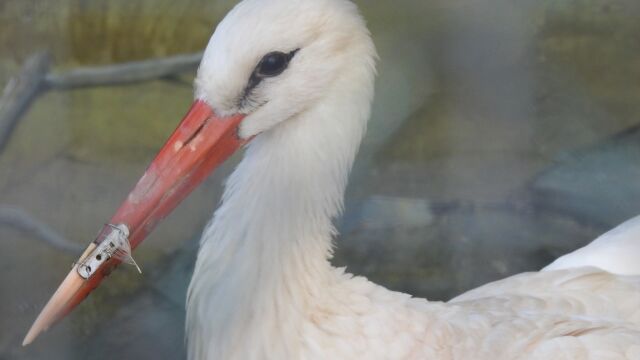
[186,0,640,359]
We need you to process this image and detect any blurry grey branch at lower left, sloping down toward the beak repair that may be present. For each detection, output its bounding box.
[0,206,82,255]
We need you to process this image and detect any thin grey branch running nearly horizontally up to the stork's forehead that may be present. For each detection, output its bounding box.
[46,52,202,90]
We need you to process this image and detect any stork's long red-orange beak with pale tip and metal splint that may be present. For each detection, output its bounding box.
[22,100,246,346]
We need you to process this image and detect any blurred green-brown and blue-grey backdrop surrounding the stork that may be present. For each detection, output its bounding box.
[0,0,640,359]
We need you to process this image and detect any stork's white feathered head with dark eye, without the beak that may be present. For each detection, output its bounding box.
[196,0,375,139]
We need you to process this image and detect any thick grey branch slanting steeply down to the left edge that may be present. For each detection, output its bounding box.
[0,52,51,152]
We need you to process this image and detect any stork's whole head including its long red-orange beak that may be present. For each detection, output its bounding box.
[23,0,375,345]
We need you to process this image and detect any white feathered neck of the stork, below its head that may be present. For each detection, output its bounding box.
[187,63,373,358]
